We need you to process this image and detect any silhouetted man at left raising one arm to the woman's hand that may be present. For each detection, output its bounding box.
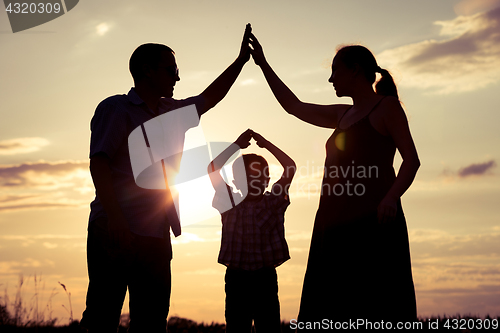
[81,25,251,333]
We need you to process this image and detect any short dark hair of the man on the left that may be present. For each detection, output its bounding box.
[129,43,175,82]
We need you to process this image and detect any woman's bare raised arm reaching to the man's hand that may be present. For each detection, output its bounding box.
[250,34,349,128]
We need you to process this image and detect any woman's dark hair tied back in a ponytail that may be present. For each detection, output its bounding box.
[329,45,399,99]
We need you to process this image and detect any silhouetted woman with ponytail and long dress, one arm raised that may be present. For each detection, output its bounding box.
[251,35,420,327]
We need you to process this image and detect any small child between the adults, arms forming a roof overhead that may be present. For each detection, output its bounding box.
[208,129,296,333]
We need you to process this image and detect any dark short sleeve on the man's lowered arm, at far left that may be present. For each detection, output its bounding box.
[89,96,128,159]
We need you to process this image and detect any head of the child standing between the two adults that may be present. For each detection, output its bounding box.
[233,154,270,198]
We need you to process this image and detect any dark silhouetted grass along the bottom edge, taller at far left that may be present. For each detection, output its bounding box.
[0,275,500,333]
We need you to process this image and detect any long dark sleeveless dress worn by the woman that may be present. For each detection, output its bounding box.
[298,98,416,322]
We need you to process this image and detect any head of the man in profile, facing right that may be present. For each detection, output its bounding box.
[129,43,180,97]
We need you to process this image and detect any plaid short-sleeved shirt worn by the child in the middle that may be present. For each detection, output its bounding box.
[213,186,290,270]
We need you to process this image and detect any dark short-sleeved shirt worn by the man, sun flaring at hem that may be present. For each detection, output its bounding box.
[89,88,204,238]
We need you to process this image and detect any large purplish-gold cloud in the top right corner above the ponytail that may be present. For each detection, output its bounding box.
[378,7,500,94]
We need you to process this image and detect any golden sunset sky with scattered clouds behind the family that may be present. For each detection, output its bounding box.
[0,0,500,323]
